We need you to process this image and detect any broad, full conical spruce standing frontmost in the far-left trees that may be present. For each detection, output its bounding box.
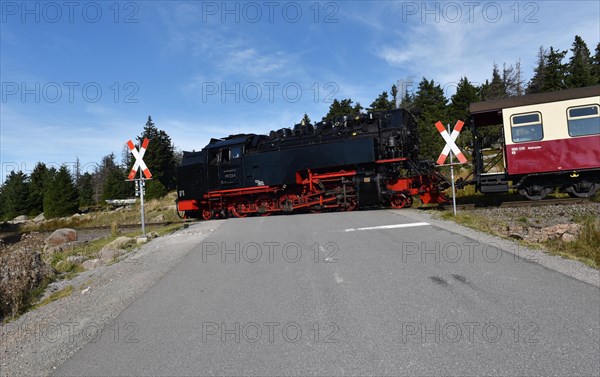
[44,165,79,219]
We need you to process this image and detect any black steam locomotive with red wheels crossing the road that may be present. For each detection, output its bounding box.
[177,109,447,220]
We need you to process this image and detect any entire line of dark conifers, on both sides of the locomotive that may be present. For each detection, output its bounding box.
[0,36,600,220]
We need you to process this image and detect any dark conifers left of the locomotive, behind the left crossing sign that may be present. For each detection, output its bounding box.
[0,116,180,220]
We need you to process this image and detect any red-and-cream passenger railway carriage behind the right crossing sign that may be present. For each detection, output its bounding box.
[470,85,600,200]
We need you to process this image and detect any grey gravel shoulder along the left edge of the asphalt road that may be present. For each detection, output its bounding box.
[0,220,223,377]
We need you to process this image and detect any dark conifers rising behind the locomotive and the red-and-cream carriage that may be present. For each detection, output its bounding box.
[312,36,600,159]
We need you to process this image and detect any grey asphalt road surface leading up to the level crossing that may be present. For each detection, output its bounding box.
[55,211,600,376]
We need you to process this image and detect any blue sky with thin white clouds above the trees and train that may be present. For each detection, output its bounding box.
[0,1,600,181]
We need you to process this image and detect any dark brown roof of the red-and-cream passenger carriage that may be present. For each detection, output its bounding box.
[469,85,600,126]
